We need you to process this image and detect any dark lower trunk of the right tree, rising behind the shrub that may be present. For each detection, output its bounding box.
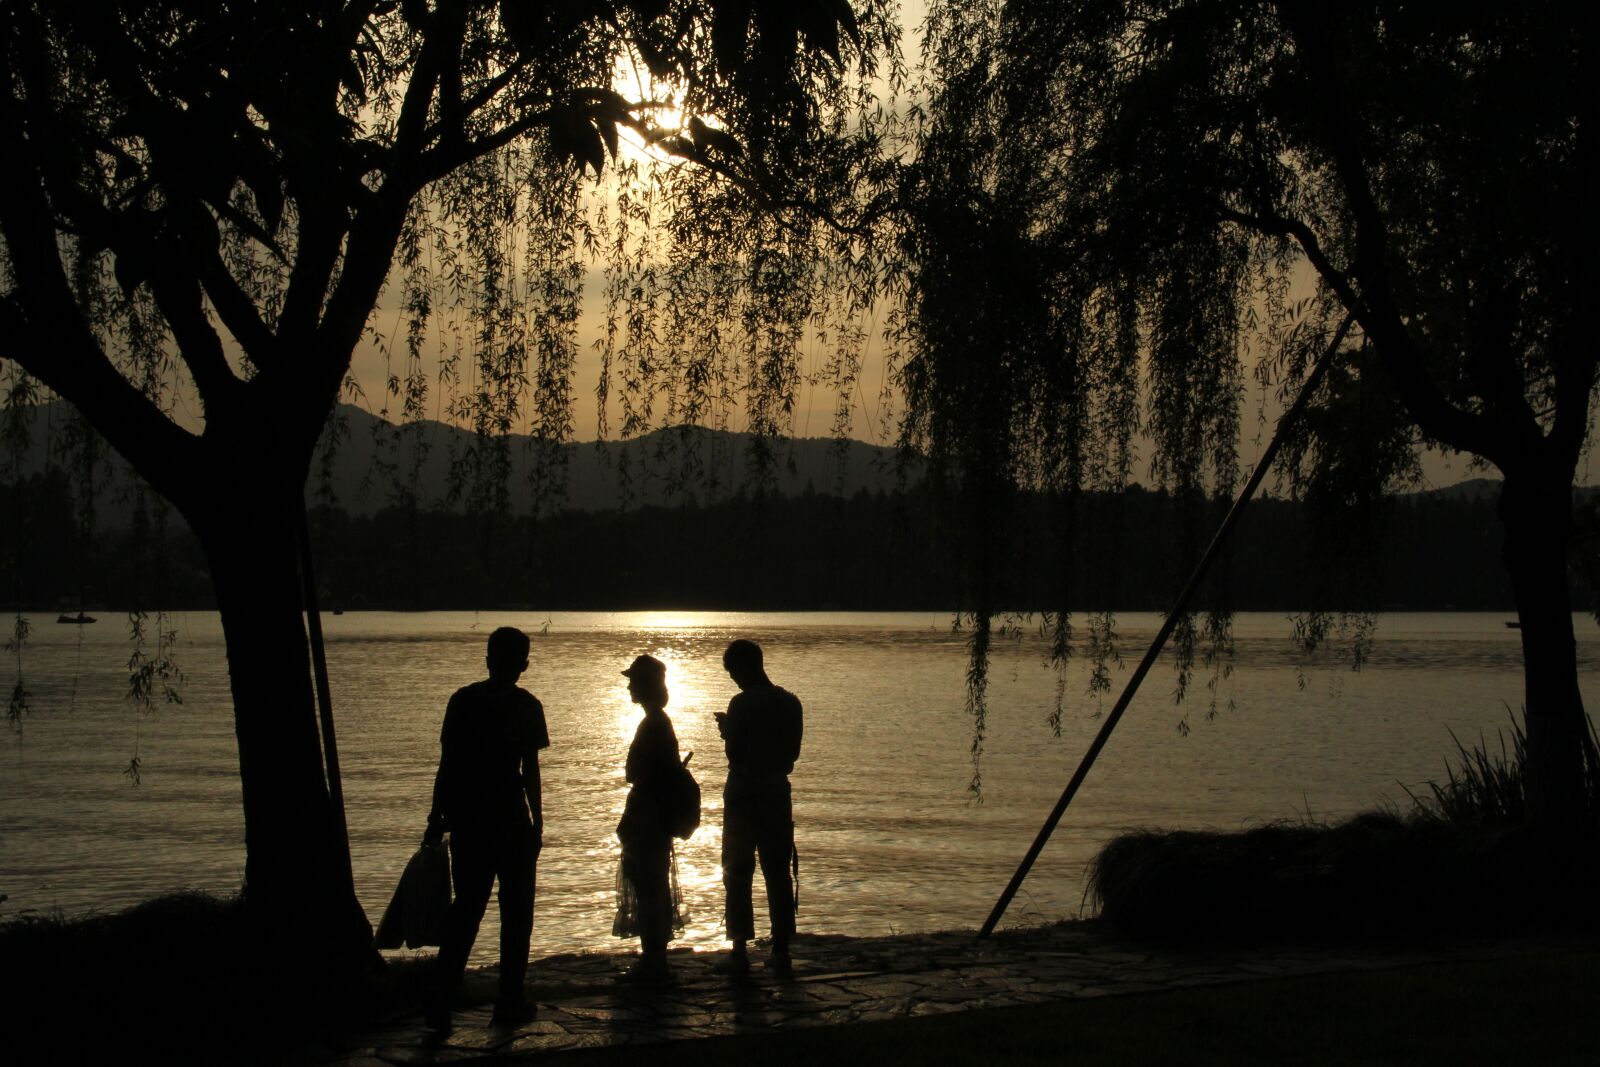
[1499,467,1589,829]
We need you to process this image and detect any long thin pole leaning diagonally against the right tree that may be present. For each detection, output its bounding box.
[978,314,1355,937]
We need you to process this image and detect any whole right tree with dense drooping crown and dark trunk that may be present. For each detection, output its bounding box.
[906,0,1600,822]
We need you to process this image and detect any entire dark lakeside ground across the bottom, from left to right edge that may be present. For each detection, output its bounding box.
[0,894,1600,1067]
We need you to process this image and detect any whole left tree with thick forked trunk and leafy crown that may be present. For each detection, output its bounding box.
[0,0,894,950]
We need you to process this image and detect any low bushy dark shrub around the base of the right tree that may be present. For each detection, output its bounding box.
[1090,723,1600,941]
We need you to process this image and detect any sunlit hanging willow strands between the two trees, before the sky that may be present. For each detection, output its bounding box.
[344,5,906,512]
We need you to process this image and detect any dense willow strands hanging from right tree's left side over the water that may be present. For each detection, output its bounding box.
[896,0,1248,790]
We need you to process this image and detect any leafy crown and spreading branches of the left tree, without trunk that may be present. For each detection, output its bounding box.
[3,0,896,483]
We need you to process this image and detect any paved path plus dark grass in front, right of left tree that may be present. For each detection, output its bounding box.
[305,923,1600,1067]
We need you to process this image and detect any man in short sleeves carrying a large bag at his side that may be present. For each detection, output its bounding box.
[424,625,550,1032]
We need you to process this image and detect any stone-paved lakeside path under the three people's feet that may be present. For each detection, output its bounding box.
[322,923,1570,1067]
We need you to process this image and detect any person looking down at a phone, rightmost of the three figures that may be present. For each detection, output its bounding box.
[714,640,803,977]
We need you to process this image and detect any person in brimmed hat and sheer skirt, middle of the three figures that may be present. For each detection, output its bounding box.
[611,656,683,982]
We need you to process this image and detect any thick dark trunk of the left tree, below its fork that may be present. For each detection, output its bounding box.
[192,489,371,973]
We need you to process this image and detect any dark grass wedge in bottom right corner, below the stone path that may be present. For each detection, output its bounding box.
[544,950,1600,1067]
